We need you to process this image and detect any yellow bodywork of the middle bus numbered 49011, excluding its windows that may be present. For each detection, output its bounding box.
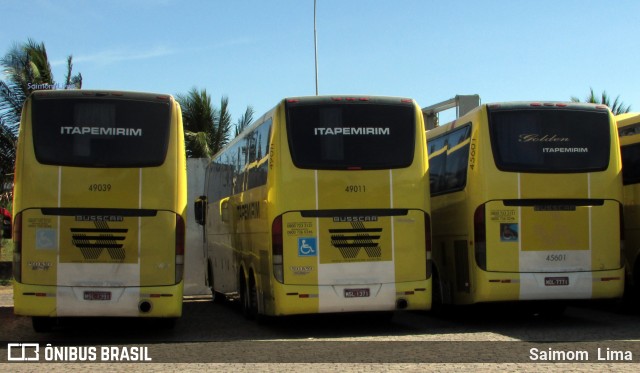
[206,97,431,316]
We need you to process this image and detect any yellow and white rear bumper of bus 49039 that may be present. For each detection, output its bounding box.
[13,282,184,317]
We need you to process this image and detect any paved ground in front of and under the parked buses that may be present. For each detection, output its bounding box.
[0,286,640,372]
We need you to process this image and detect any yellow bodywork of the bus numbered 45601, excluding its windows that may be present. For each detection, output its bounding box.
[427,104,624,304]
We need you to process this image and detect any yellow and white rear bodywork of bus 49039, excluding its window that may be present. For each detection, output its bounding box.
[13,94,186,317]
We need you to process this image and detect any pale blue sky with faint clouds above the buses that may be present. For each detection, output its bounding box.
[0,0,640,122]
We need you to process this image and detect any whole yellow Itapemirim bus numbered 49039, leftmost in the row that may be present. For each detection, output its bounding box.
[13,90,187,331]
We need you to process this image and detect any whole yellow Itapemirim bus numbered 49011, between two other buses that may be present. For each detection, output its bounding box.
[194,96,431,318]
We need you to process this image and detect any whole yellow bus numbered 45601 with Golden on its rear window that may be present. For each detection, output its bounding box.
[427,102,624,313]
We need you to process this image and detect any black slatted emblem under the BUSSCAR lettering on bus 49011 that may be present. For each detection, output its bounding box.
[329,217,382,259]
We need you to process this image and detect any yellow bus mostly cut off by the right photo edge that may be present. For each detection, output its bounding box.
[616,113,640,299]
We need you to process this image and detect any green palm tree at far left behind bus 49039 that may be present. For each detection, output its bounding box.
[0,39,82,198]
